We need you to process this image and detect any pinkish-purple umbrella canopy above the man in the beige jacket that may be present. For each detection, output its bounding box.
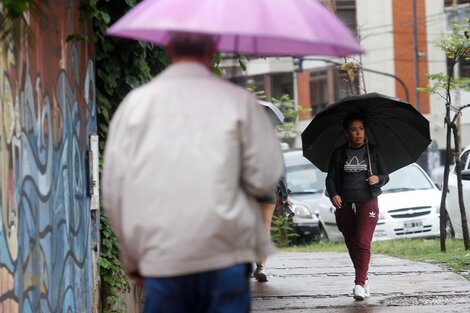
[107,0,362,56]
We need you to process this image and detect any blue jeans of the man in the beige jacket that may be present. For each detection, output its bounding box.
[143,264,251,313]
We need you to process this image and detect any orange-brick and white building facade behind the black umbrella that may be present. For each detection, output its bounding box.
[227,0,470,154]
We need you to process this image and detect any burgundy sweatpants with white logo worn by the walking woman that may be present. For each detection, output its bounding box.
[335,198,379,286]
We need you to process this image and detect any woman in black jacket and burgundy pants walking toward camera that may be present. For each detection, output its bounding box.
[326,113,389,300]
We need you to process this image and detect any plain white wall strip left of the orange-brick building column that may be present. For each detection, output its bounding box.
[356,0,396,96]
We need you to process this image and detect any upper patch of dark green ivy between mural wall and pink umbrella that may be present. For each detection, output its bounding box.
[82,0,169,148]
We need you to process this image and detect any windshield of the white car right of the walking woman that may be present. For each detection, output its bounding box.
[382,165,434,193]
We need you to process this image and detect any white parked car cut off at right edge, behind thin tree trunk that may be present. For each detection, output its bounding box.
[446,146,470,238]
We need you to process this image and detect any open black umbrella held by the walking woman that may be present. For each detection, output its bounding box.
[302,93,431,172]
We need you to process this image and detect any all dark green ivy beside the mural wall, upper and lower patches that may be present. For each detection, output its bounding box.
[78,0,169,313]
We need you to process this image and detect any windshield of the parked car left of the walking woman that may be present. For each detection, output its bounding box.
[287,164,326,194]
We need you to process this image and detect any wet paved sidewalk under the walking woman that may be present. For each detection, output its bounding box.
[251,253,470,313]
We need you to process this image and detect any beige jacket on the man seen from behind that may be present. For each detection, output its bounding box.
[102,62,283,277]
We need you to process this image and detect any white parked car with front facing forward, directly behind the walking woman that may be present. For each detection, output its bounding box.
[319,164,441,240]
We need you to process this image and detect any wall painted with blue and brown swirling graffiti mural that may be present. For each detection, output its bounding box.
[0,0,97,313]
